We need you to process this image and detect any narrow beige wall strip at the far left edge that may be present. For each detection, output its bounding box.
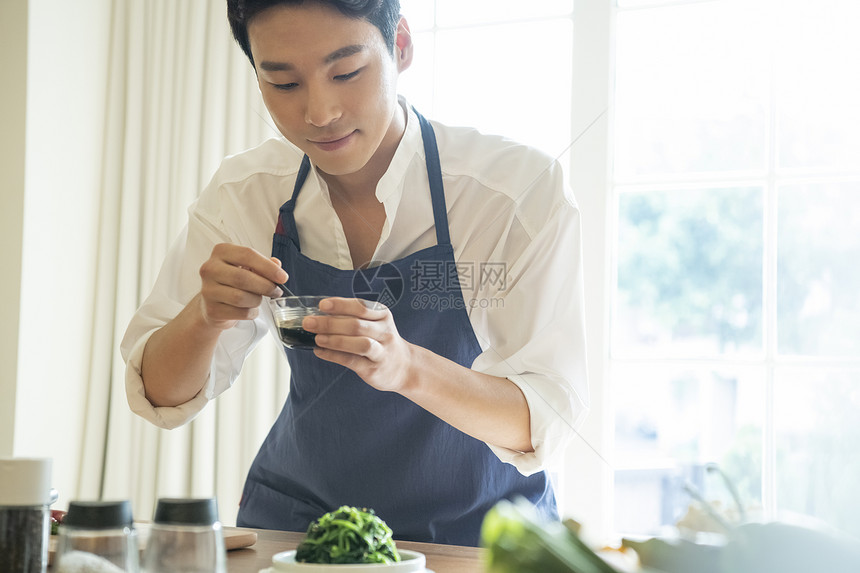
[0,0,27,456]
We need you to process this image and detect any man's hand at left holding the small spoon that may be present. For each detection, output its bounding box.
[199,243,288,330]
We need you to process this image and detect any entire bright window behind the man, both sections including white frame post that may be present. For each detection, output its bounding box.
[401,0,860,535]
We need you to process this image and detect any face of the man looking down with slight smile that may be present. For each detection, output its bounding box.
[248,2,408,176]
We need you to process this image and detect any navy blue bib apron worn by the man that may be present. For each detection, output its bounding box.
[237,108,557,545]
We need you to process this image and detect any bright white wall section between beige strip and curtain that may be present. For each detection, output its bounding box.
[5,0,110,498]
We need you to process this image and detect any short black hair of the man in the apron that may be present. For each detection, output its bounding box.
[227,0,400,66]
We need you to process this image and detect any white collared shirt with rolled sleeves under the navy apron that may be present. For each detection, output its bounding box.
[121,100,588,475]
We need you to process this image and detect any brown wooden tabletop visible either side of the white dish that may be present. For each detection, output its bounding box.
[227,529,484,573]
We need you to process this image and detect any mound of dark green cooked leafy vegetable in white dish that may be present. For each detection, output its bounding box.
[296,505,400,563]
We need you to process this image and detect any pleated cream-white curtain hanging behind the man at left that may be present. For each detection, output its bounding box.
[77,0,288,525]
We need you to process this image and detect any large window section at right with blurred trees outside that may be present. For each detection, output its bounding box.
[610,0,860,534]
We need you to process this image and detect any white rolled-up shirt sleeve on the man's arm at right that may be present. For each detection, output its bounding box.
[472,197,589,475]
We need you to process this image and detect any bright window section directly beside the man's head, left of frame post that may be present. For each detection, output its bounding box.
[400,0,573,157]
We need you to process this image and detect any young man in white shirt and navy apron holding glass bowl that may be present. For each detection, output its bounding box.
[123,0,588,545]
